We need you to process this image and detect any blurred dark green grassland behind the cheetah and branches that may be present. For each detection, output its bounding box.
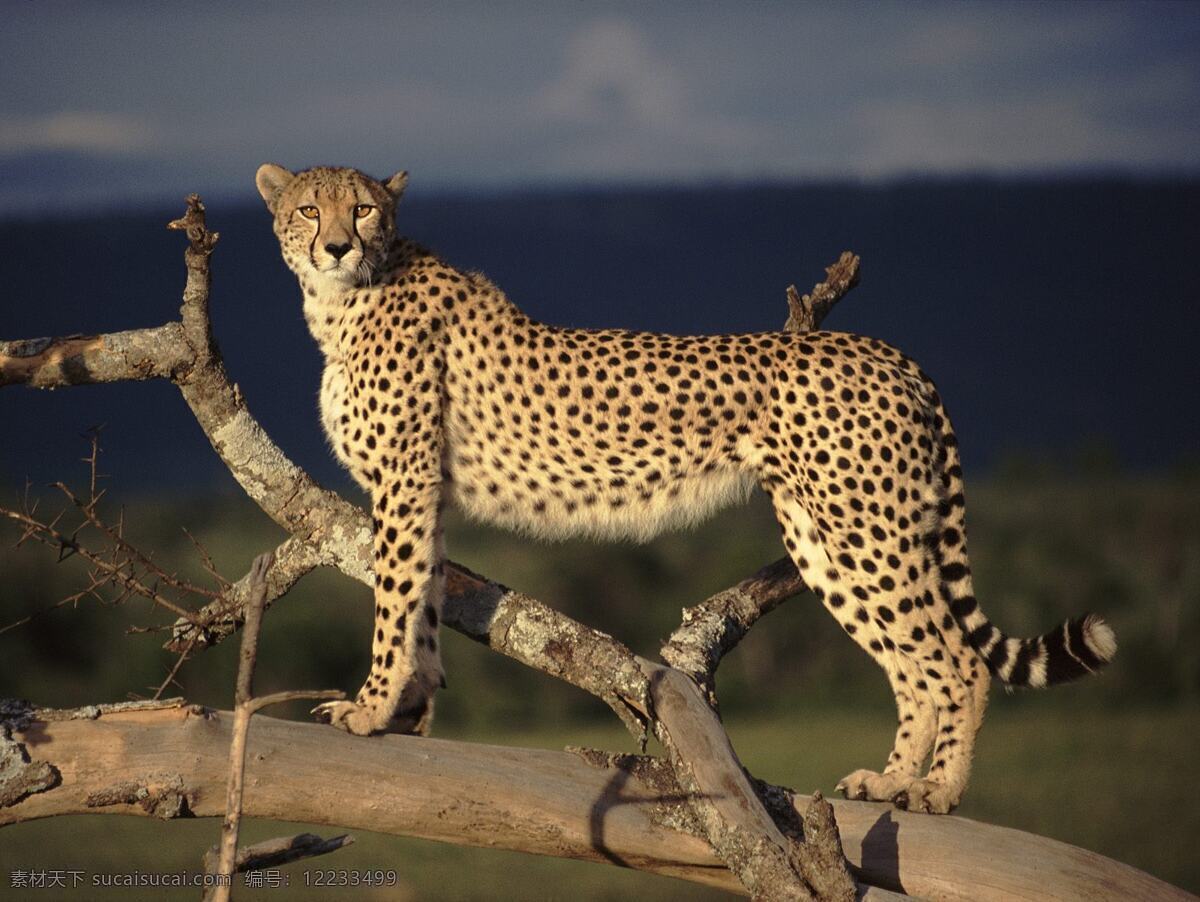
[0,468,1200,900]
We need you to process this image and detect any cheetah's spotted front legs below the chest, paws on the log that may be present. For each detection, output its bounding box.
[313,470,443,735]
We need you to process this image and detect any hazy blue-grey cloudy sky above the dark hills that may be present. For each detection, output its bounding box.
[0,1,1200,211]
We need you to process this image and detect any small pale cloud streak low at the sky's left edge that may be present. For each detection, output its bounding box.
[0,110,156,156]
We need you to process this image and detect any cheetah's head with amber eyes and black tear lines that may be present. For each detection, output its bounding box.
[254,163,408,294]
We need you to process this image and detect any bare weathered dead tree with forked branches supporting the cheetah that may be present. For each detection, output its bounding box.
[0,194,1186,900]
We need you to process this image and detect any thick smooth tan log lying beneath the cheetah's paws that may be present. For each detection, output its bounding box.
[0,704,1192,902]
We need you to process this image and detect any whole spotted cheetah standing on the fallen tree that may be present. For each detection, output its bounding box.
[256,163,1116,813]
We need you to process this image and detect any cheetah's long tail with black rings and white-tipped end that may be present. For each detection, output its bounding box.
[930,398,1117,688]
